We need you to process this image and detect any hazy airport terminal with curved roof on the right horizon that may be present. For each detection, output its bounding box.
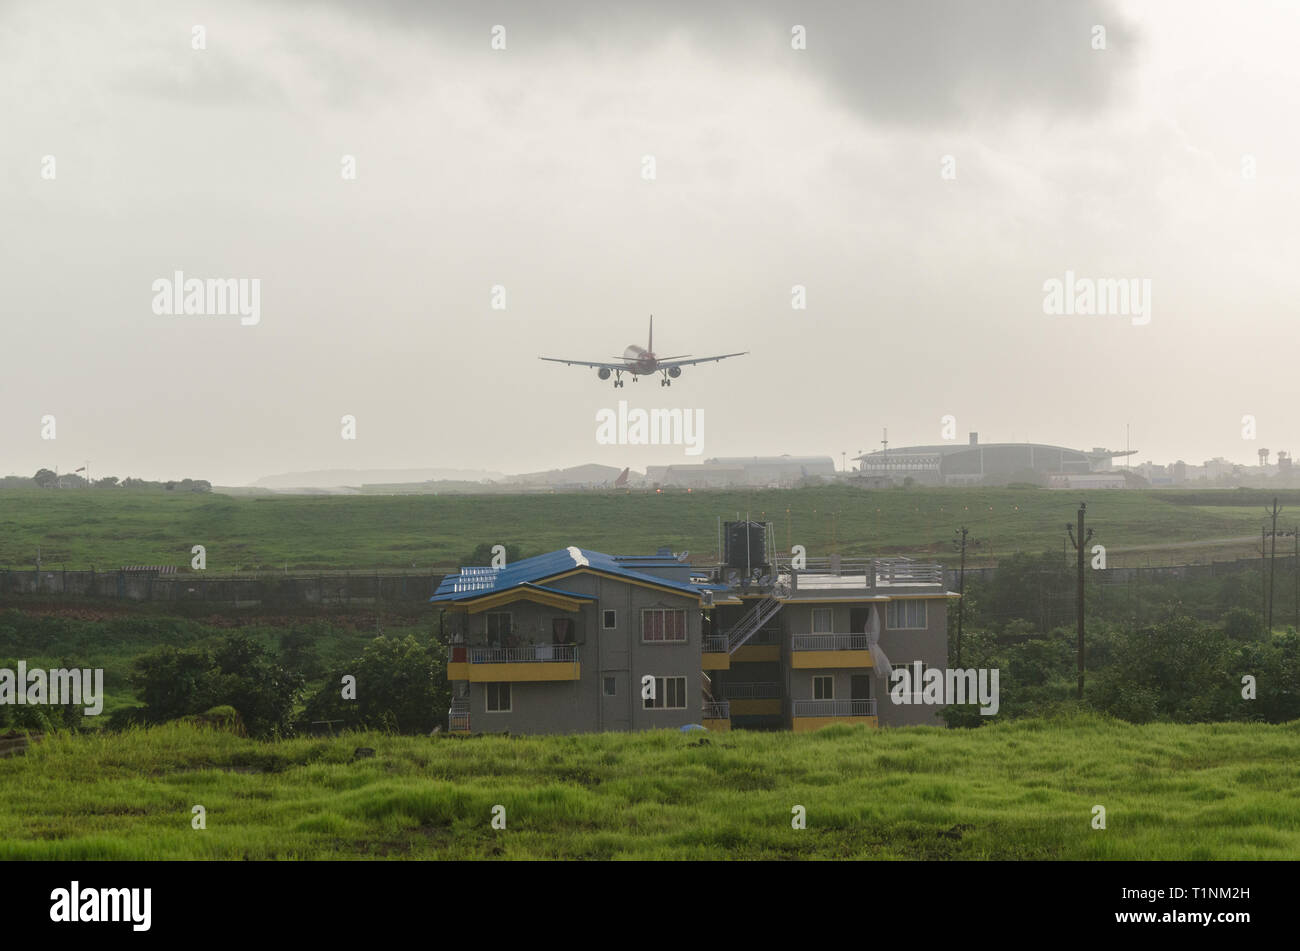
[853,433,1138,486]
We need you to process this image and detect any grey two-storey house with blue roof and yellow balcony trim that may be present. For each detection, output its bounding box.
[430,522,957,734]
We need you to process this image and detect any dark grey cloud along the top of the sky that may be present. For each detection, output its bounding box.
[301,0,1140,125]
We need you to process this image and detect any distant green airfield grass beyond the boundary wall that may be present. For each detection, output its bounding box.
[0,486,1300,573]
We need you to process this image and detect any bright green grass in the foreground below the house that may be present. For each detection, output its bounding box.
[0,716,1300,859]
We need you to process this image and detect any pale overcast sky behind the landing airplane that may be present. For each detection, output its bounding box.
[0,0,1300,485]
